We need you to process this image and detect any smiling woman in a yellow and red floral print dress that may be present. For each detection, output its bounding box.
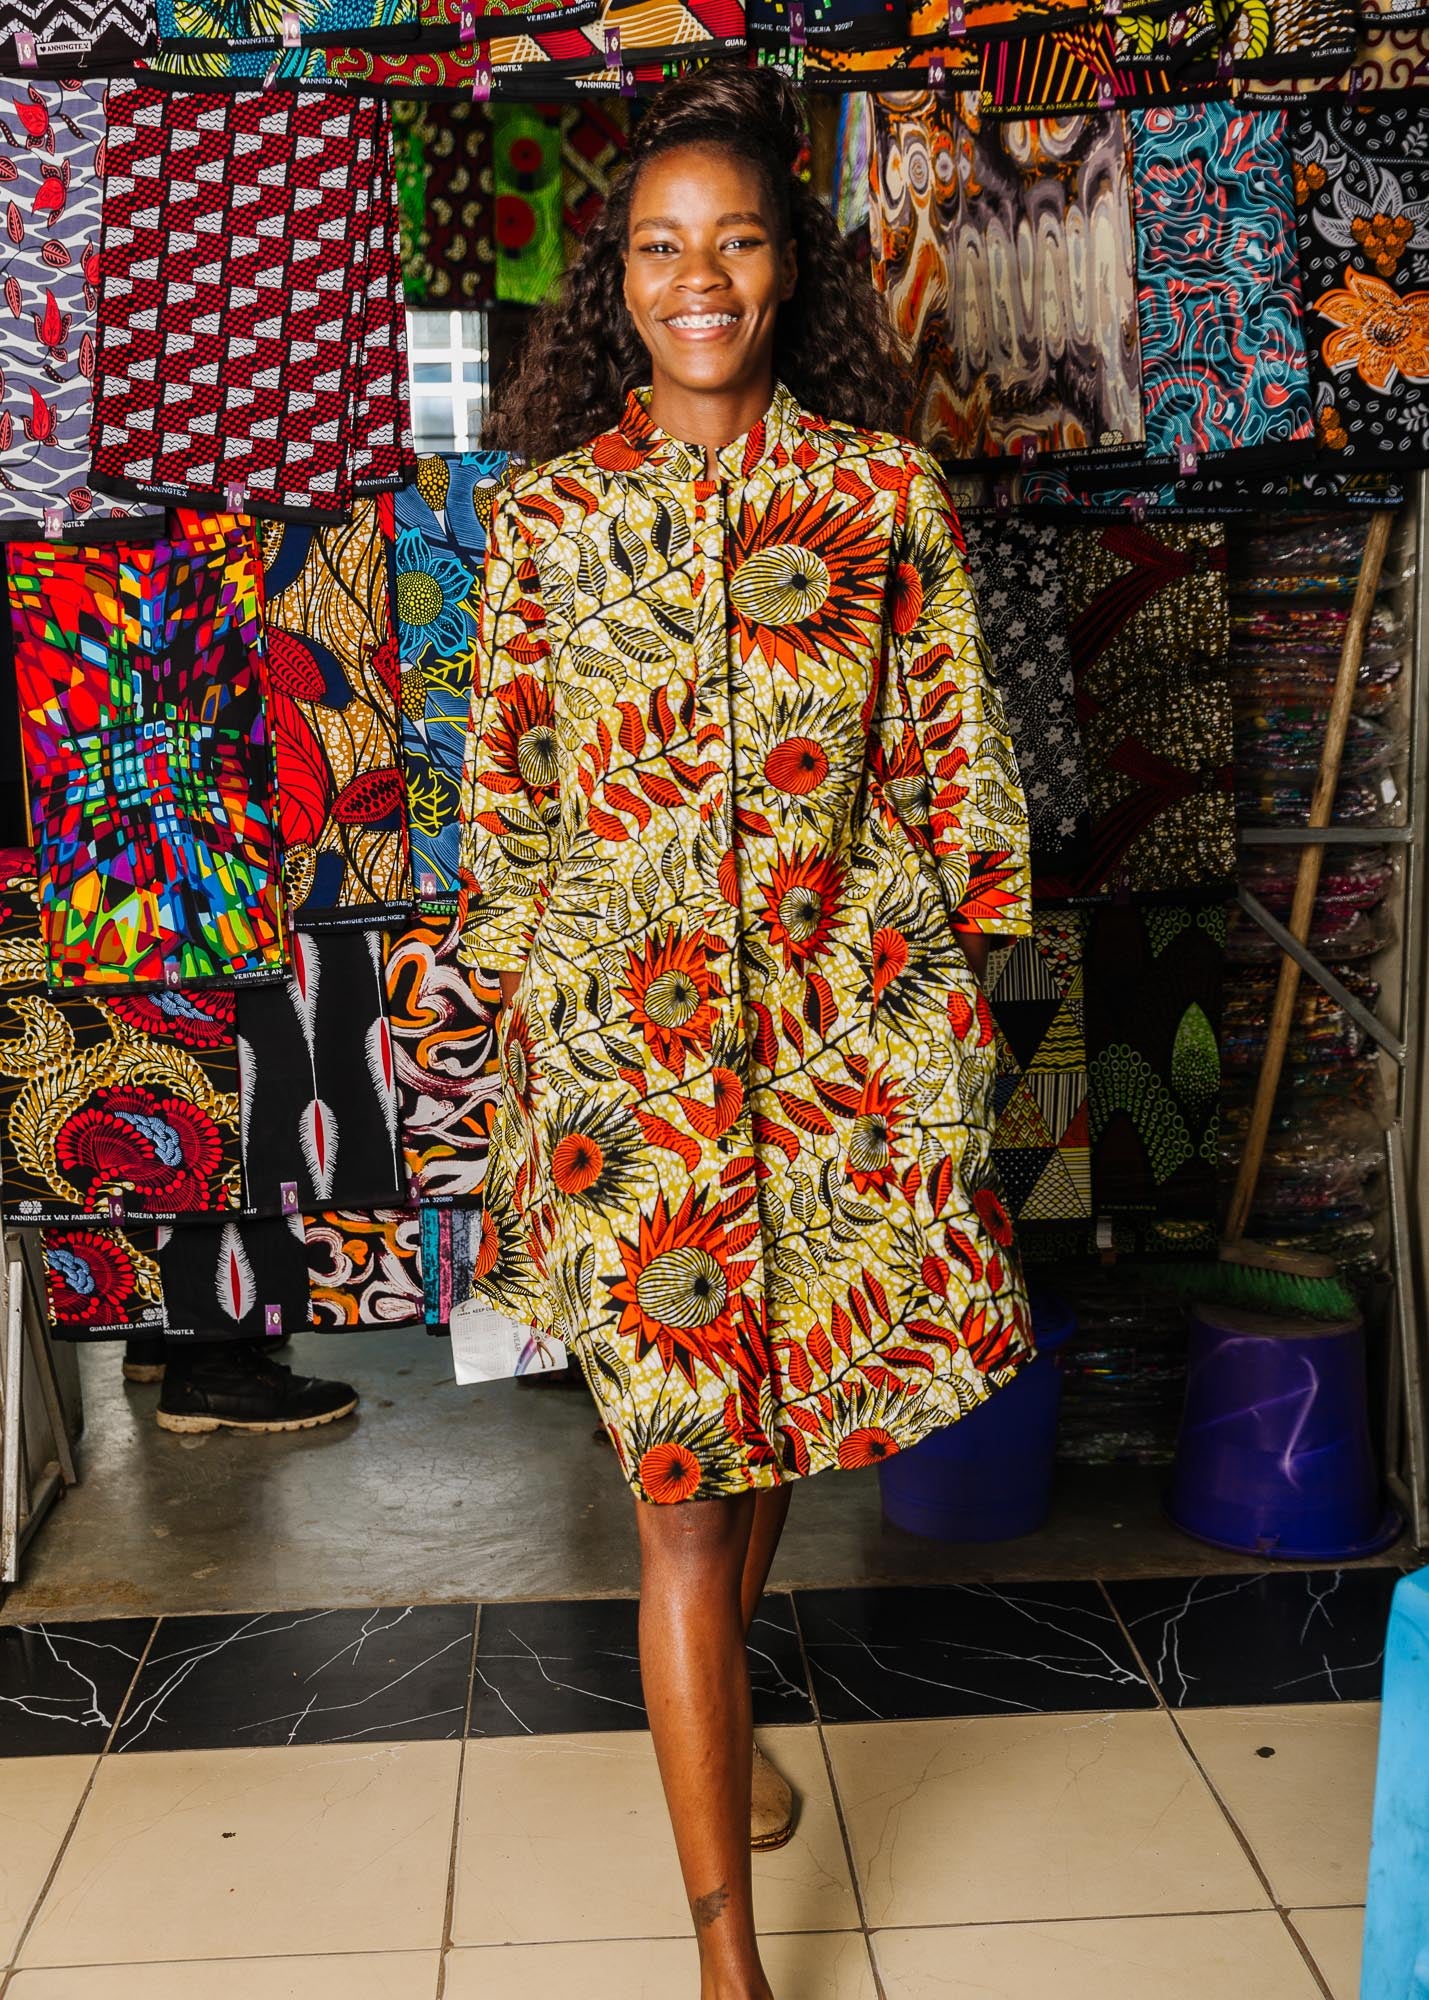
[462,70,1029,2000]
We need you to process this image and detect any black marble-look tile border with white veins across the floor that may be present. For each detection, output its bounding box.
[0,1560,1419,1762]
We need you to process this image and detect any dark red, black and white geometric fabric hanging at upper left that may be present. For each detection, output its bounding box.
[90,78,416,522]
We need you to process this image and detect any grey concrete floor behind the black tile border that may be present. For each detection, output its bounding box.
[0,1330,1393,1622]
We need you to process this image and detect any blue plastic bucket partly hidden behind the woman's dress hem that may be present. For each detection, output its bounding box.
[879,1298,1077,1542]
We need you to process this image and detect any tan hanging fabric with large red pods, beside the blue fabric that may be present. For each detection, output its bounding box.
[258,500,412,928]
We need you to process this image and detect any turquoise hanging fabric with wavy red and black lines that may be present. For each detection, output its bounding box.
[1129,104,1313,474]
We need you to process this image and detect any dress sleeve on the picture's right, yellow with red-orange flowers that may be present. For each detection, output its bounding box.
[873,454,1031,936]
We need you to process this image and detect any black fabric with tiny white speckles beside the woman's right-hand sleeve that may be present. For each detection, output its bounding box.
[963,514,1087,868]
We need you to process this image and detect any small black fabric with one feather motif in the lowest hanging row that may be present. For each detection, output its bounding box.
[158,1216,310,1340]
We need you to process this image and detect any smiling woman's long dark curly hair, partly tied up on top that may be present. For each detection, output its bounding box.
[482,64,907,464]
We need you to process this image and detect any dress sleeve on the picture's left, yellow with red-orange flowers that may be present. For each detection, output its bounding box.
[456,494,560,972]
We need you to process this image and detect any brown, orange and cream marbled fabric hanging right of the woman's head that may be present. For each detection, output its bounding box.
[875,92,1143,462]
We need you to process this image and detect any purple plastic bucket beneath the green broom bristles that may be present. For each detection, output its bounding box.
[1167,1304,1403,1562]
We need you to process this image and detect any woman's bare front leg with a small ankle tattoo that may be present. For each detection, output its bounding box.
[636,1494,773,2000]
